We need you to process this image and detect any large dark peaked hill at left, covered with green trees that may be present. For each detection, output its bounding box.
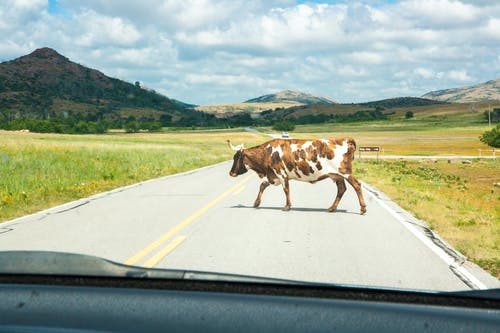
[0,48,210,129]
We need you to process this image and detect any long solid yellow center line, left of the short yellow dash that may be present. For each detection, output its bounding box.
[125,174,253,265]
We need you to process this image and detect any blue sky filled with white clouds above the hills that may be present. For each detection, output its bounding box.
[0,0,500,105]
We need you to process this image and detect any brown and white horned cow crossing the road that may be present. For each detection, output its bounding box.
[227,138,366,214]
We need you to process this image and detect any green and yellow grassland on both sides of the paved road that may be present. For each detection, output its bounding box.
[0,121,500,277]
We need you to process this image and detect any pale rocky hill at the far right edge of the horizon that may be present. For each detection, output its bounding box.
[422,78,500,103]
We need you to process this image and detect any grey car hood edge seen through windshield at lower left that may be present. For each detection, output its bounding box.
[0,251,302,285]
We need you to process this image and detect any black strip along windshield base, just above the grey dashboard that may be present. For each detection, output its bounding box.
[0,274,500,309]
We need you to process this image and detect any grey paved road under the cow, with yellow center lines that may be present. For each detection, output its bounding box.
[0,162,498,290]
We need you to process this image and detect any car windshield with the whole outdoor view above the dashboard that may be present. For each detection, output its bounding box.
[0,0,500,292]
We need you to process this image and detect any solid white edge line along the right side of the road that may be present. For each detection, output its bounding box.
[363,185,488,290]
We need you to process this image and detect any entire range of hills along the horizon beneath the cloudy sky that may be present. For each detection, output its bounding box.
[0,48,500,128]
